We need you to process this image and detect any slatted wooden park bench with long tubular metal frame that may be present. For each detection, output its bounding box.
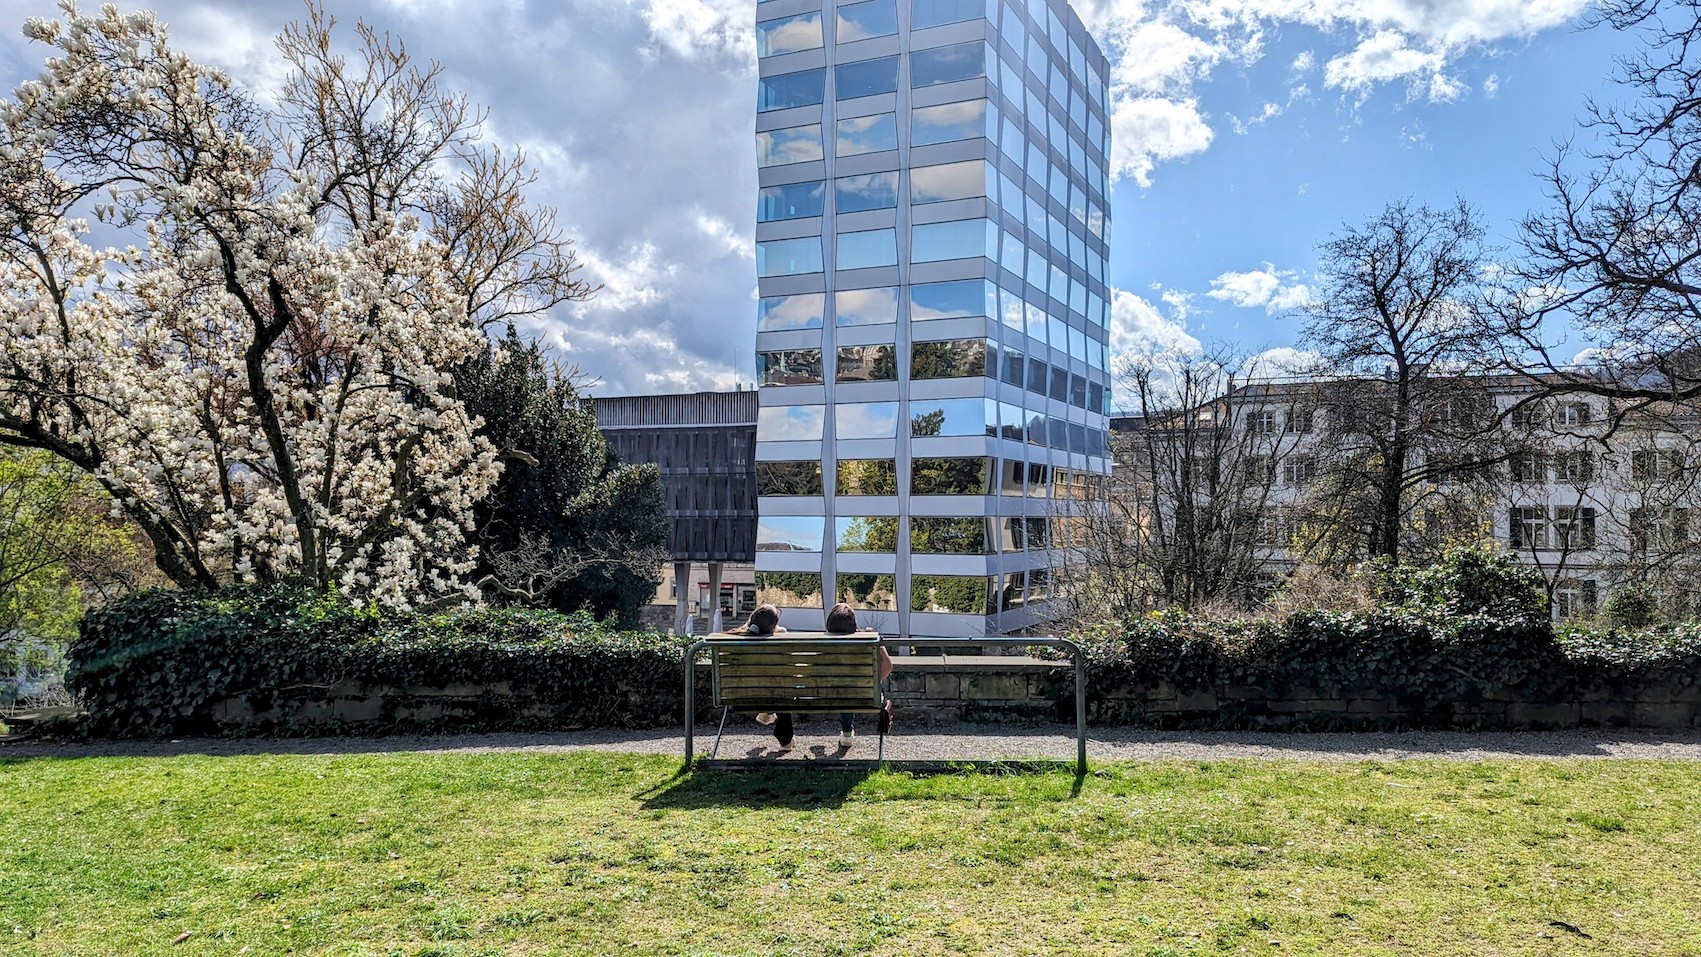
[686,631,1087,775]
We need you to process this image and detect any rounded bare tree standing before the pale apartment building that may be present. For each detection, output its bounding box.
[1303,201,1504,561]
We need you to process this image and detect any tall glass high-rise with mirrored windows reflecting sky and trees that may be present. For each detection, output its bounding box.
[757,0,1109,637]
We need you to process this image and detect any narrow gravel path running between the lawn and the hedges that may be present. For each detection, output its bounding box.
[0,719,1701,762]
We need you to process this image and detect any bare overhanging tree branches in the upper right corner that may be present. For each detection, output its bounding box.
[1517,0,1701,411]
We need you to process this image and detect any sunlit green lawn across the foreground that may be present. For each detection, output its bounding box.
[0,753,1701,957]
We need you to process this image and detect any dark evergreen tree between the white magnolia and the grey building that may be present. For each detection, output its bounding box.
[456,328,670,626]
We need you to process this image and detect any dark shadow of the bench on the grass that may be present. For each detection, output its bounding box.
[634,760,1084,811]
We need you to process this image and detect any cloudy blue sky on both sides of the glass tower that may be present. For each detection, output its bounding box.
[0,0,1630,394]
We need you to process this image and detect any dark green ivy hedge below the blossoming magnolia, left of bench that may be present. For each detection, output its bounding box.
[68,585,682,734]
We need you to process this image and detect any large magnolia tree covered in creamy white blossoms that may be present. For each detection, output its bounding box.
[0,2,589,607]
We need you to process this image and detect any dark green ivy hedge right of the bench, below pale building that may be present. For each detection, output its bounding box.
[1087,547,1701,728]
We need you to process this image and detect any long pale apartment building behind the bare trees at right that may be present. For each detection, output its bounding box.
[1116,376,1701,617]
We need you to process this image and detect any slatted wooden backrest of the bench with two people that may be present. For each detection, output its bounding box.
[709,632,885,712]
